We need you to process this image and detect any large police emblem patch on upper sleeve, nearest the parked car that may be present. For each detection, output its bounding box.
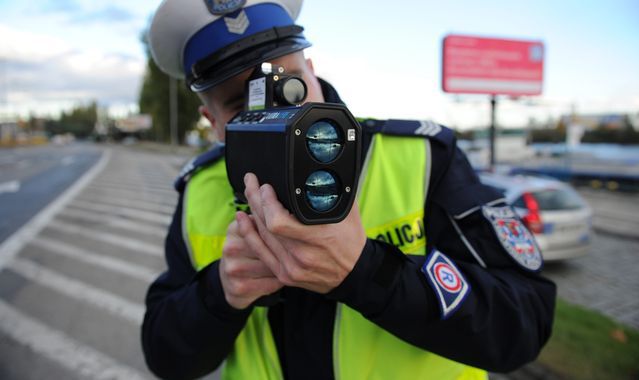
[482,206,543,272]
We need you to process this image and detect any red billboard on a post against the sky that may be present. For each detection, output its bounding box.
[442,35,544,96]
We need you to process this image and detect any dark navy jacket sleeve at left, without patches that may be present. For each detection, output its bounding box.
[142,196,250,379]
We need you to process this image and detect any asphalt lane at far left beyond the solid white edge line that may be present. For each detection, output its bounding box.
[0,144,100,241]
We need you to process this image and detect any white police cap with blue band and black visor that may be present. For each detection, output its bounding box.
[149,0,310,92]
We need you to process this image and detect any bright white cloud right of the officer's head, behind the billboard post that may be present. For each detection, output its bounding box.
[307,47,639,130]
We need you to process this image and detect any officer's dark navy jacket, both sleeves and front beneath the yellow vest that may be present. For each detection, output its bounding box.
[142,81,556,379]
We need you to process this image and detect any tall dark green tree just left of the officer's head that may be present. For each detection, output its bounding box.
[138,32,200,143]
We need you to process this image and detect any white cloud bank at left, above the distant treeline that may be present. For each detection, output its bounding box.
[0,25,146,114]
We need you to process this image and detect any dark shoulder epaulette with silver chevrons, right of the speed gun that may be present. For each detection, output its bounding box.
[360,119,455,144]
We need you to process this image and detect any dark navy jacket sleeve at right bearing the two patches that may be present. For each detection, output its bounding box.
[329,142,556,372]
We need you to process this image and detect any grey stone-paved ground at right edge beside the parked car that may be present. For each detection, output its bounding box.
[544,188,639,329]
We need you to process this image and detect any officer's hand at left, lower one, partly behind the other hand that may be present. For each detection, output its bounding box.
[220,211,282,309]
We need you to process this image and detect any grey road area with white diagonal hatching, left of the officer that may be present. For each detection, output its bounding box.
[0,147,185,379]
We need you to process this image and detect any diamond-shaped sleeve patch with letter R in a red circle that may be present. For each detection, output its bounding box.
[422,249,470,319]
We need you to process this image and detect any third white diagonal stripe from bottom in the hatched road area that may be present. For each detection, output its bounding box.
[30,235,159,283]
